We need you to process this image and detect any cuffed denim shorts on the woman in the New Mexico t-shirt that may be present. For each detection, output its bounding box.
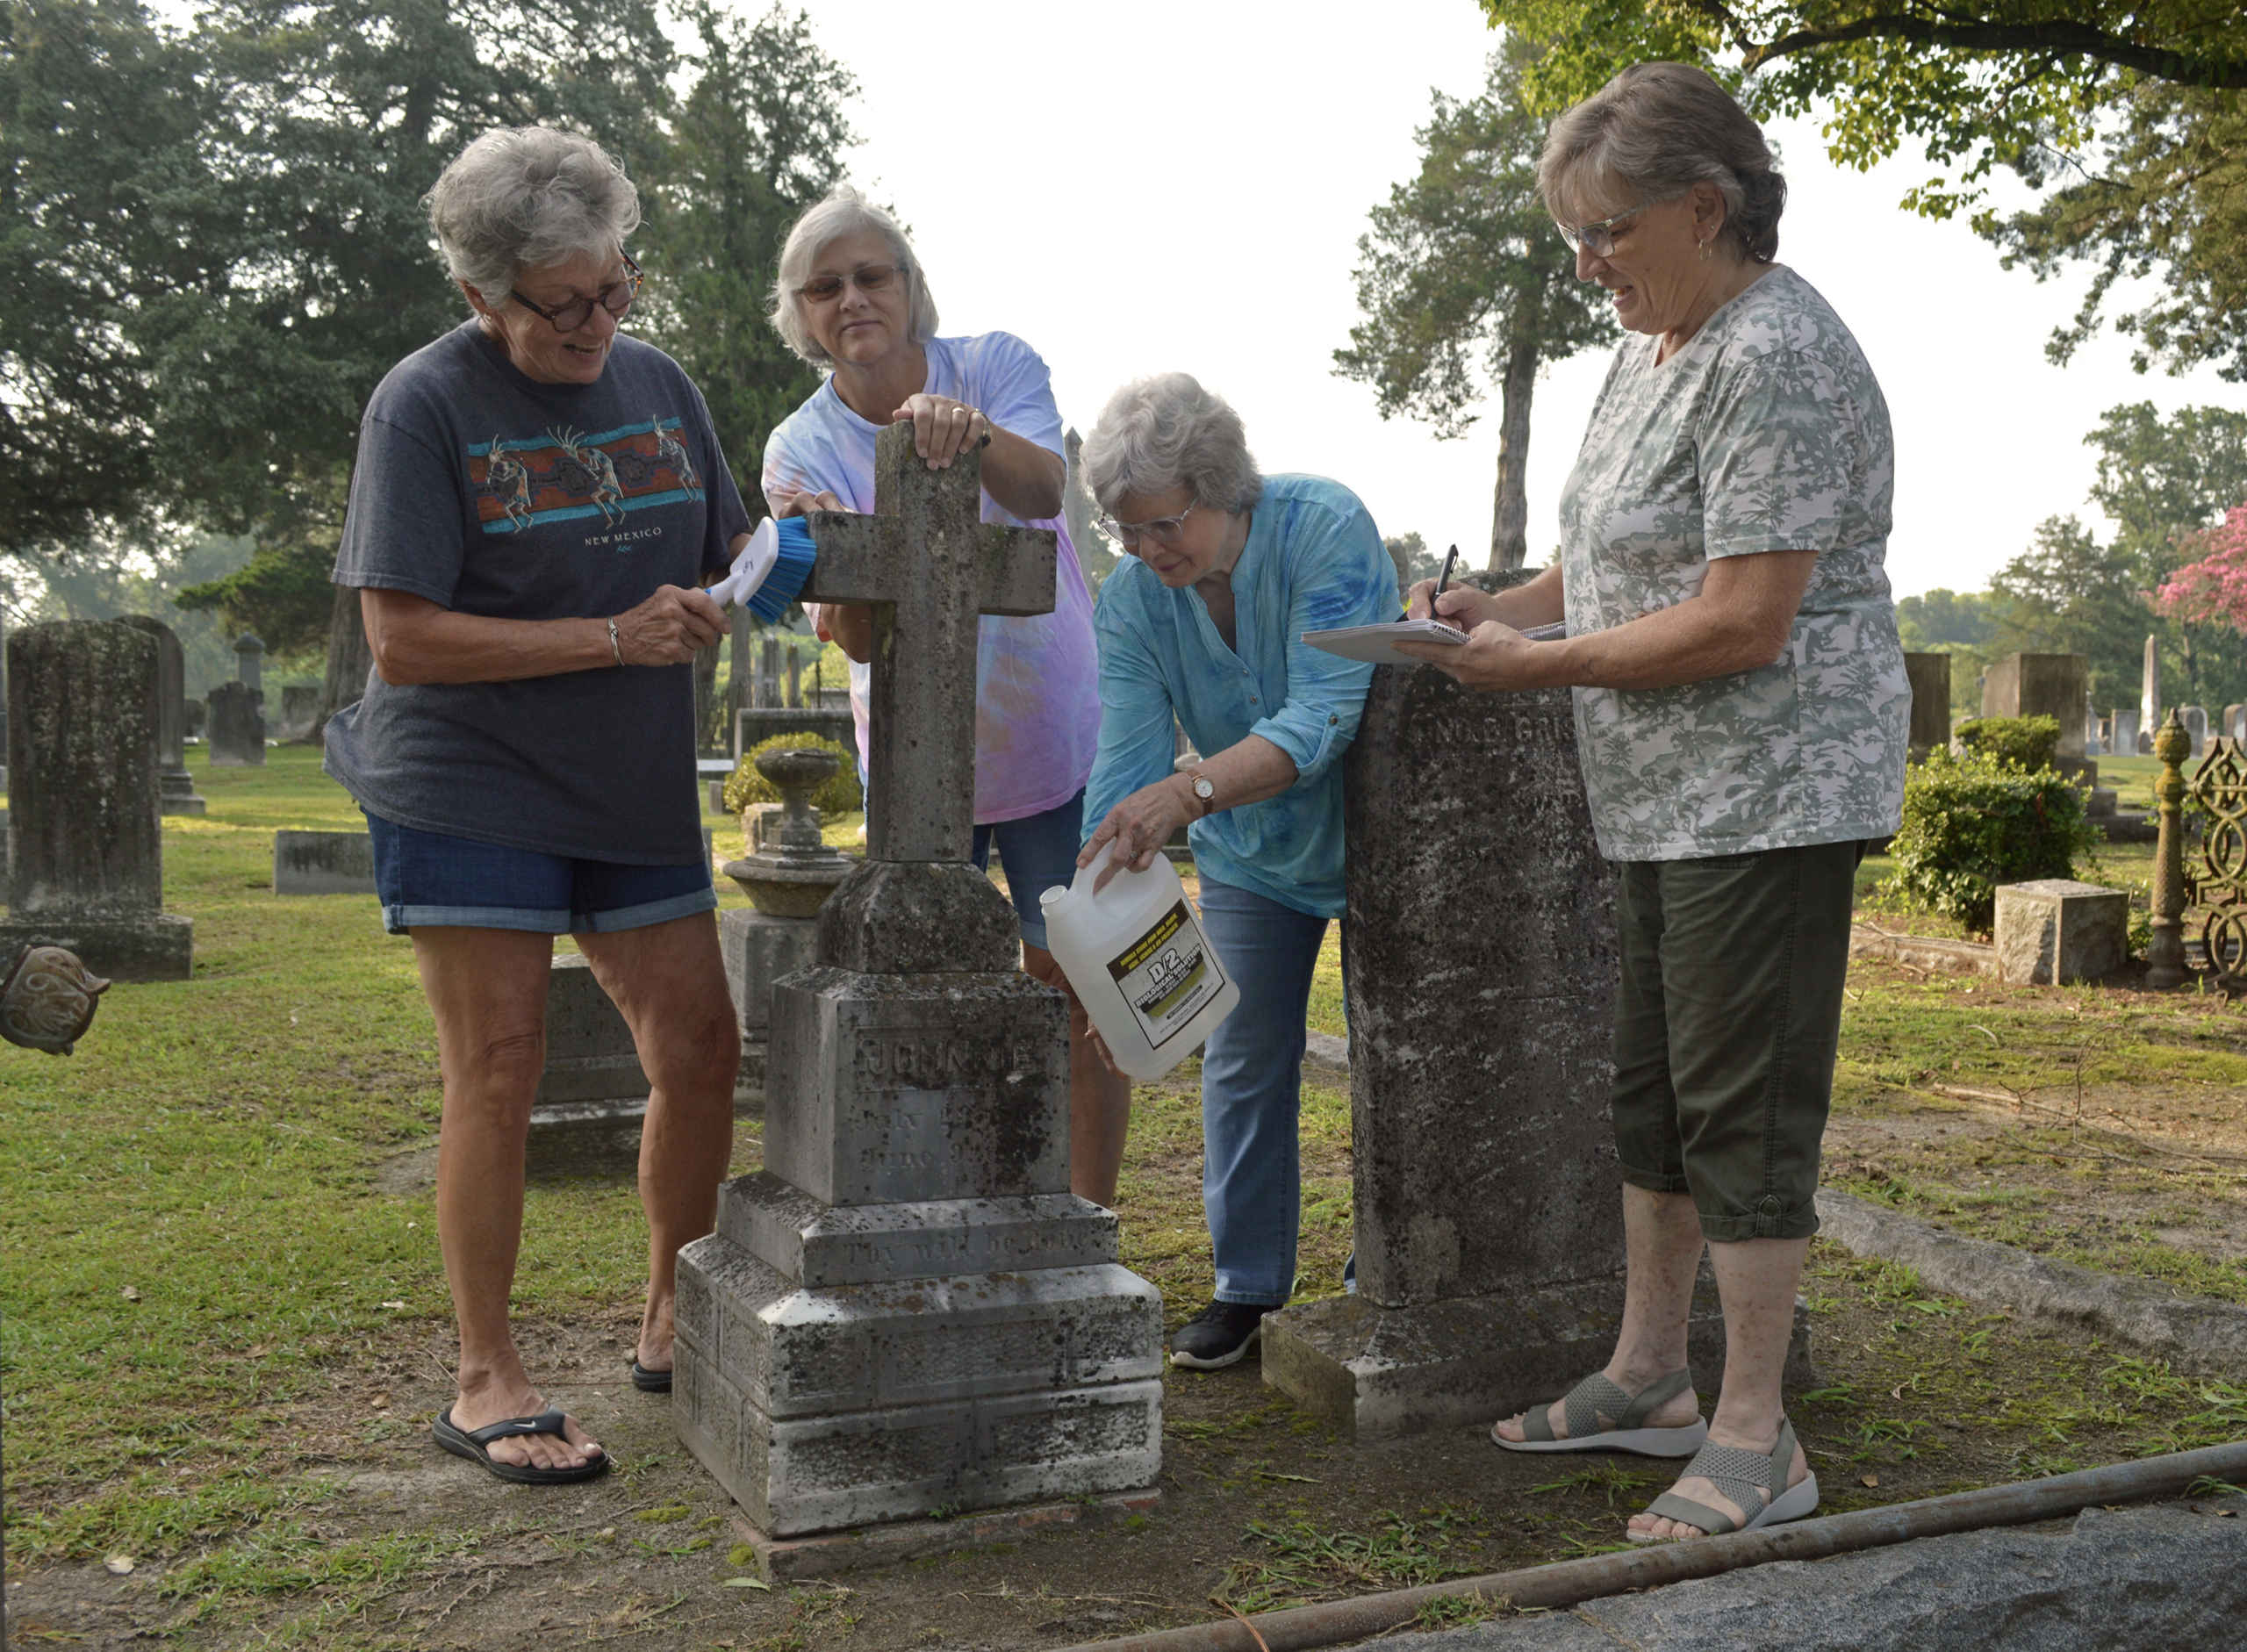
[362,811,717,935]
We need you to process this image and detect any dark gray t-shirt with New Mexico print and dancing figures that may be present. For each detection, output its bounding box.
[326,321,750,866]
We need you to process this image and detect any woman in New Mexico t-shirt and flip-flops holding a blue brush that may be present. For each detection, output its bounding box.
[326,128,750,1483]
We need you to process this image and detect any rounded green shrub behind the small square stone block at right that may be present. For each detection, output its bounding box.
[1887,751,2099,935]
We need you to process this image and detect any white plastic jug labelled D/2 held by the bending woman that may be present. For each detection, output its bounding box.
[1038,843,1240,1079]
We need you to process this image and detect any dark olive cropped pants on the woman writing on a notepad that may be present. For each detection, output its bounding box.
[1612,843,1865,1240]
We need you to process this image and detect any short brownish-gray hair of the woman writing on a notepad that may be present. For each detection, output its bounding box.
[1537,63,1786,263]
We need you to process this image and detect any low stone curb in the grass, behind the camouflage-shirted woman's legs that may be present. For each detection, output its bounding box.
[1818,1187,2247,1378]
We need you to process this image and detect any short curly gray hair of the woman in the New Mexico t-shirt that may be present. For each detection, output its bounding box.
[422,126,641,304]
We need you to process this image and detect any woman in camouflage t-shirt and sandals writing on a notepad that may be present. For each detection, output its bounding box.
[1411,63,1910,1542]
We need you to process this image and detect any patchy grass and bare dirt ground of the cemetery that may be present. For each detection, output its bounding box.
[0,746,2247,1652]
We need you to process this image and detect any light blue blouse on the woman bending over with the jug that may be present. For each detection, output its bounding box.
[1083,477,1397,917]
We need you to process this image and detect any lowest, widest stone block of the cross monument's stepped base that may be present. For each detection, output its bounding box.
[671,1232,1162,1537]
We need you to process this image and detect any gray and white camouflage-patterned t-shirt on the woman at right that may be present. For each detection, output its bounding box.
[1560,265,1913,861]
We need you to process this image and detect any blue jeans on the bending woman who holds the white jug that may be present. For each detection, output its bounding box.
[1202,877,1325,1308]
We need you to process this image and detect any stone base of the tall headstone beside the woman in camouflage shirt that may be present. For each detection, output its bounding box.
[1263,1268,1811,1440]
